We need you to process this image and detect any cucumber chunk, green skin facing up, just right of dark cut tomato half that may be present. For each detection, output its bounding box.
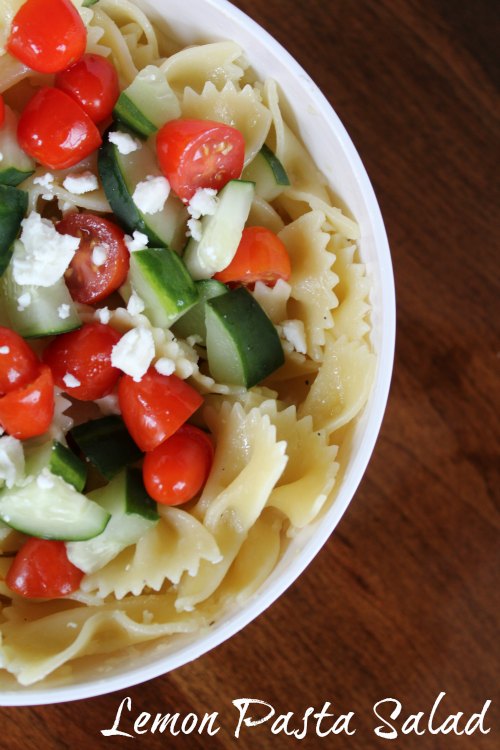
[121,247,198,328]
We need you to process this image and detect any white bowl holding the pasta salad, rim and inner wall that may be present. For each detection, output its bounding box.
[0,0,395,706]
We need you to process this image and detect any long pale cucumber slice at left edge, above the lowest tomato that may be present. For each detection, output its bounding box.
[0,470,110,541]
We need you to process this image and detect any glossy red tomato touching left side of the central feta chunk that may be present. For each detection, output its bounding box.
[42,323,121,401]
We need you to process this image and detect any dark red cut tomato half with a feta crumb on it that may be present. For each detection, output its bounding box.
[56,213,130,305]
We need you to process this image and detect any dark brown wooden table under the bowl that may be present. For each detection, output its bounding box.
[0,0,500,750]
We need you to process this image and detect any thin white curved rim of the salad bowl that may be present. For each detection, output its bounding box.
[0,0,396,707]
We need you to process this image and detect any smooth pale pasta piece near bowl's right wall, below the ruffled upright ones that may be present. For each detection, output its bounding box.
[299,334,376,433]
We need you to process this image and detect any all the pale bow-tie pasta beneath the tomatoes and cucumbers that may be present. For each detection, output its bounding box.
[0,0,375,685]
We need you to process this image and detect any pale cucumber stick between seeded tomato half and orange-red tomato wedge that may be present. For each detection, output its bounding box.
[183,180,255,280]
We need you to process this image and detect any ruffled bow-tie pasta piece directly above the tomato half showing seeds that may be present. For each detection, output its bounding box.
[181,81,271,164]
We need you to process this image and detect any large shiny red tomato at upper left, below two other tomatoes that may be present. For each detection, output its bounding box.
[17,87,102,169]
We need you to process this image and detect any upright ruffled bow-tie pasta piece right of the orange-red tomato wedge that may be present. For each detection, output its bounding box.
[279,211,338,361]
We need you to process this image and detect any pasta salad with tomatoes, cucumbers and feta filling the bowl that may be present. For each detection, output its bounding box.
[0,0,375,685]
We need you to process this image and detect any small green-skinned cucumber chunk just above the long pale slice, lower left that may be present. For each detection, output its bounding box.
[25,440,87,492]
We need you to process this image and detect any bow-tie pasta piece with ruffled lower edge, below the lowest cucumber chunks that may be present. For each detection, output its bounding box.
[81,506,221,599]
